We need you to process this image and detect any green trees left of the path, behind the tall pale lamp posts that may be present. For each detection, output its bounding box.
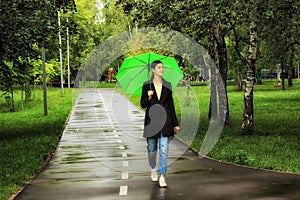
[0,0,101,111]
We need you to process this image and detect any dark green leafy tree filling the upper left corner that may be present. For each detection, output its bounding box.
[0,0,75,111]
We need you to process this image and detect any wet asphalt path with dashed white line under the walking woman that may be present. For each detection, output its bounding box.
[15,89,300,200]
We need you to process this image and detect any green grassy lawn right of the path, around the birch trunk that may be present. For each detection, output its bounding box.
[125,80,300,173]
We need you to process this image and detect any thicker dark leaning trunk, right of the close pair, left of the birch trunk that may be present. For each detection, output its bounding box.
[214,24,229,125]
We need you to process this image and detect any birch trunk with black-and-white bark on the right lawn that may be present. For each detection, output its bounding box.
[242,22,258,134]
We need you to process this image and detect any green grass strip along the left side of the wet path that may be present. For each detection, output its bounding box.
[0,89,78,199]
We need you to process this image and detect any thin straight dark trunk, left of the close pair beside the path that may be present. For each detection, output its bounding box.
[208,26,218,119]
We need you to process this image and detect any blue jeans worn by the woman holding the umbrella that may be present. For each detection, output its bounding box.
[147,133,170,175]
